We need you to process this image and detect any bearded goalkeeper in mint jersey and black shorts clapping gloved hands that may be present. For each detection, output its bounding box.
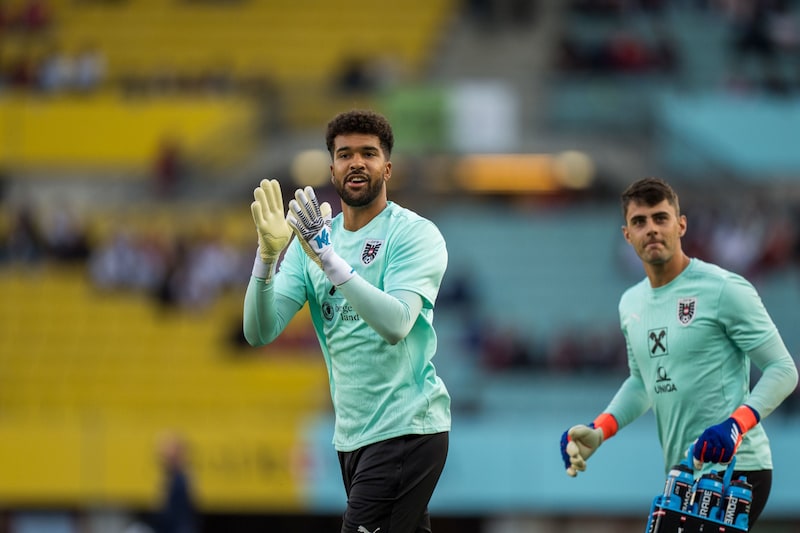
[244,110,450,533]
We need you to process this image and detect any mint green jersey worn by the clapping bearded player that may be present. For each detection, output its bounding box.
[275,202,450,451]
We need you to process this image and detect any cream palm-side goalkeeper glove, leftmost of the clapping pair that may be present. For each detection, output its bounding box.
[250,179,292,278]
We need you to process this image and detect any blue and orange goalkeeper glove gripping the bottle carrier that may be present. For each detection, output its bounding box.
[692,405,761,470]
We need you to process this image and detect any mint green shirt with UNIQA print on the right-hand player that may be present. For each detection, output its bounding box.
[606,259,797,470]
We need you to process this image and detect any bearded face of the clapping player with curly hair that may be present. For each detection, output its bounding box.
[331,133,392,207]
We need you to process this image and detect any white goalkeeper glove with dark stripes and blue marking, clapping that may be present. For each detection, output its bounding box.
[286,187,355,286]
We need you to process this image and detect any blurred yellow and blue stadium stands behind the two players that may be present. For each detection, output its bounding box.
[0,0,800,533]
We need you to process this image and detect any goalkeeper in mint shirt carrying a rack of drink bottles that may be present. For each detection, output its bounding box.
[561,178,797,526]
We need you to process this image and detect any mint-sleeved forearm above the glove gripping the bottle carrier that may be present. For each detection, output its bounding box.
[745,334,797,419]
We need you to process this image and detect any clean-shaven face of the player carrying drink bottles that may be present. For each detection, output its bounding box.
[622,200,686,265]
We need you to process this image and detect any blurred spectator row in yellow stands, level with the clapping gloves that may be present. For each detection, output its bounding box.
[0,200,253,312]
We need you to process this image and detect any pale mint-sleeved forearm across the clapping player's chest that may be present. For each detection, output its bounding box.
[338,275,422,344]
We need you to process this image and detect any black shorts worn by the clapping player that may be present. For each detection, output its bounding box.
[339,432,449,533]
